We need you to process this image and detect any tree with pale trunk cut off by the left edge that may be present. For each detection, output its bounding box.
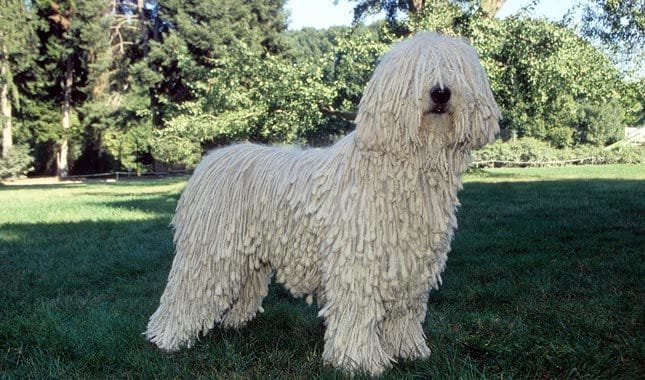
[0,0,35,158]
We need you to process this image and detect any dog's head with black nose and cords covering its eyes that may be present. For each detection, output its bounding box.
[356,32,500,156]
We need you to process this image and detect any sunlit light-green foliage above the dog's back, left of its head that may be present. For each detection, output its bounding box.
[153,22,388,165]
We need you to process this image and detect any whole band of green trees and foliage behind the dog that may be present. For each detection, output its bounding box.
[0,0,645,175]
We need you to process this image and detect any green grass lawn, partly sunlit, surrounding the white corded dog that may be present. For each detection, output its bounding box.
[0,165,645,379]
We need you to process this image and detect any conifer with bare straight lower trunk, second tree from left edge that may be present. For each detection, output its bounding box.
[34,0,110,177]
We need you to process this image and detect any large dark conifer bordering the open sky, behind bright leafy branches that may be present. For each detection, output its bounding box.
[142,0,286,164]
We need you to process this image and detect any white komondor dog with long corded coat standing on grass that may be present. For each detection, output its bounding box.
[146,33,500,375]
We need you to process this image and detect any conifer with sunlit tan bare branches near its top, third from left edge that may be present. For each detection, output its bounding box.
[73,0,155,172]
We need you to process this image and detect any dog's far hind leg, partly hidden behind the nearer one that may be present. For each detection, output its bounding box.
[222,258,273,328]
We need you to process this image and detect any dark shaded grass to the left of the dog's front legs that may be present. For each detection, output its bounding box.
[0,215,334,378]
